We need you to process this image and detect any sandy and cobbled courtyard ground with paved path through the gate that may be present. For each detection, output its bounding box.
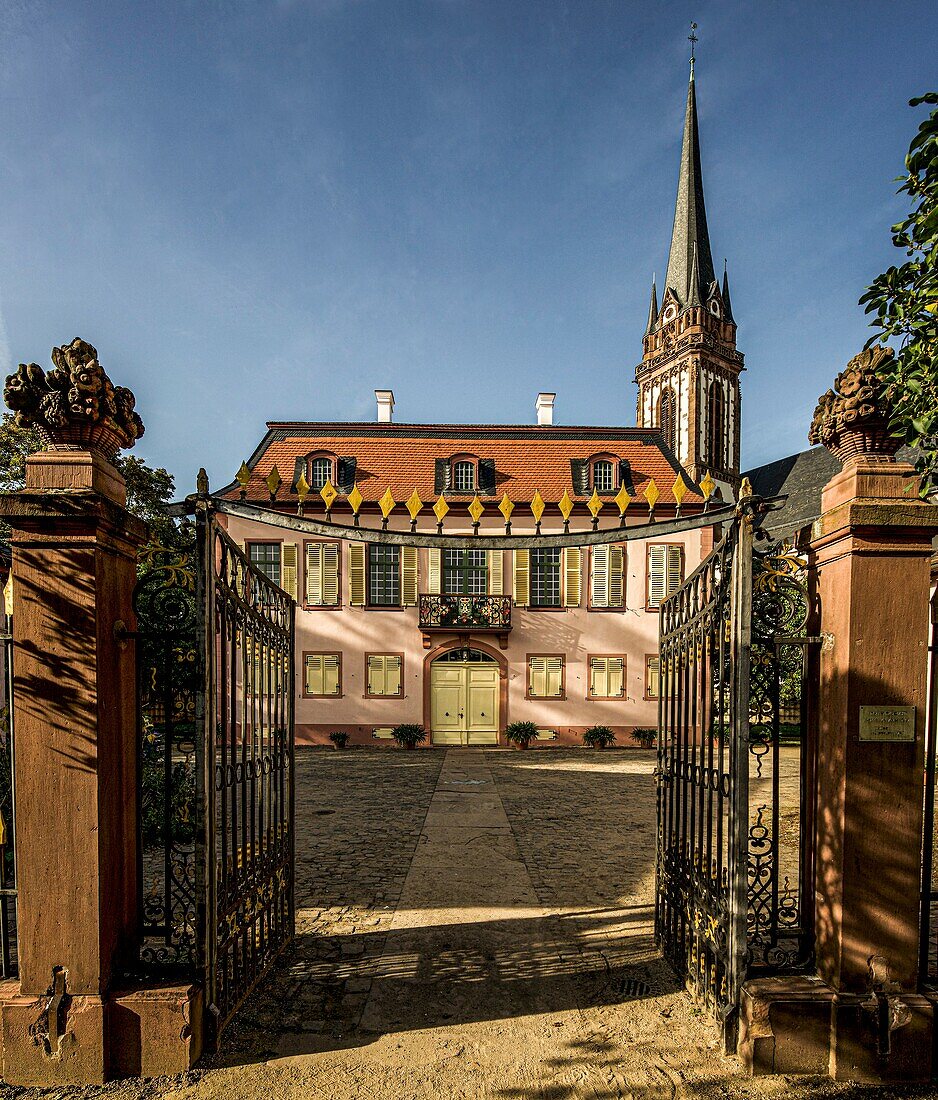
[0,750,936,1100]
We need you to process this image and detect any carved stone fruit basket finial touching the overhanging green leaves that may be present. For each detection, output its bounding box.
[808,345,902,464]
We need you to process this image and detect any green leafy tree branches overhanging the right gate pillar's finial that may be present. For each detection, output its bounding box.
[860,91,938,496]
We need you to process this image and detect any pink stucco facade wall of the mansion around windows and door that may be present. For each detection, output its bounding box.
[223,517,713,747]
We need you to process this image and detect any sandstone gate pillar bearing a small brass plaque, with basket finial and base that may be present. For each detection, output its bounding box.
[740,349,938,1081]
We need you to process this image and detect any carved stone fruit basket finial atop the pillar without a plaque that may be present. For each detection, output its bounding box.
[3,337,144,460]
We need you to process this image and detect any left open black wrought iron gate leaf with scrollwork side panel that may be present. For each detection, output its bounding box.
[134,499,295,1042]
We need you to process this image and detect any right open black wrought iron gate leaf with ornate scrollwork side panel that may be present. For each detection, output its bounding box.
[655,498,818,1051]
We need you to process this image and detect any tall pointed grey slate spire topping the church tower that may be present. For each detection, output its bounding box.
[664,65,714,305]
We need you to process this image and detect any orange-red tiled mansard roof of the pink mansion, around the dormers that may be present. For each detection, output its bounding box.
[221,422,702,508]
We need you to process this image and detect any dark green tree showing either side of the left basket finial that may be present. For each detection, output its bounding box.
[0,413,176,545]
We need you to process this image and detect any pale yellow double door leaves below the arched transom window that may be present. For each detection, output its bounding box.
[430,661,498,745]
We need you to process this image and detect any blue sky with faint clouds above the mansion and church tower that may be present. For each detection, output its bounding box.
[0,0,938,493]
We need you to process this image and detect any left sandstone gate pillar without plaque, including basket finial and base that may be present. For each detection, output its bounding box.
[0,340,201,1085]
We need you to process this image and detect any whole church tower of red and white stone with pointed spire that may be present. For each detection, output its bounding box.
[636,55,743,496]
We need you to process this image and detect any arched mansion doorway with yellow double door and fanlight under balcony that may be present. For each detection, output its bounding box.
[424,642,505,746]
